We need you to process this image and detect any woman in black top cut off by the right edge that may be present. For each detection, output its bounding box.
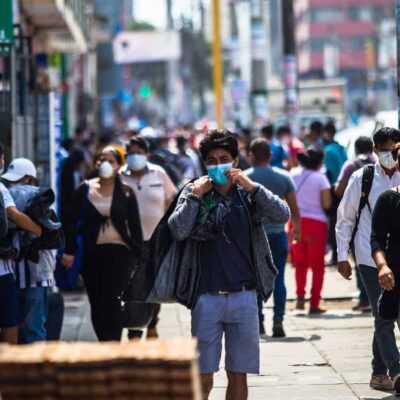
[371,144,400,319]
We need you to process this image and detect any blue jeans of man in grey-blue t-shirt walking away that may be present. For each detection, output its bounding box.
[258,232,289,322]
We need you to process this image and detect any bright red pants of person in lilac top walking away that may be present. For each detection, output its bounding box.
[292,218,328,308]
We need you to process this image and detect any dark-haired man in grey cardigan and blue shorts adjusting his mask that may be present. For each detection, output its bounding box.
[168,130,290,400]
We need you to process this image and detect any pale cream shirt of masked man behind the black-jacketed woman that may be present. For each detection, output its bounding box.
[121,162,177,240]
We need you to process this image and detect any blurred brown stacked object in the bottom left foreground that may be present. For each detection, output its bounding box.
[0,339,200,400]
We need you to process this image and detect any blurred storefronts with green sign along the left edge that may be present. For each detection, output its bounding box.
[0,0,91,188]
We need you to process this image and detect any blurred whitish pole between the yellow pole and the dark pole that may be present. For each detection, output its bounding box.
[251,0,268,124]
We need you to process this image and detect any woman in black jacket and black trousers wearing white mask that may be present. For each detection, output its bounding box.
[61,146,143,341]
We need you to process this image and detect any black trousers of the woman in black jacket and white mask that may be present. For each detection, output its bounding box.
[82,244,131,342]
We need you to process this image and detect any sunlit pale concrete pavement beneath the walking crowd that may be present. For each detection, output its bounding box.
[62,266,397,400]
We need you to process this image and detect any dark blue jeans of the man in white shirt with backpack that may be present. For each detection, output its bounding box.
[359,265,400,378]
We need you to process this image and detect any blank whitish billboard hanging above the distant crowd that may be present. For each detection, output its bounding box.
[113,31,181,64]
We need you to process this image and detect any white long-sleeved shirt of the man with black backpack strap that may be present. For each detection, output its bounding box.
[336,163,400,268]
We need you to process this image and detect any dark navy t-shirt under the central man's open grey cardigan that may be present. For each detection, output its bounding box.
[200,187,255,293]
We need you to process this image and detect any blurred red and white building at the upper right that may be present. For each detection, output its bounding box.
[295,0,396,113]
